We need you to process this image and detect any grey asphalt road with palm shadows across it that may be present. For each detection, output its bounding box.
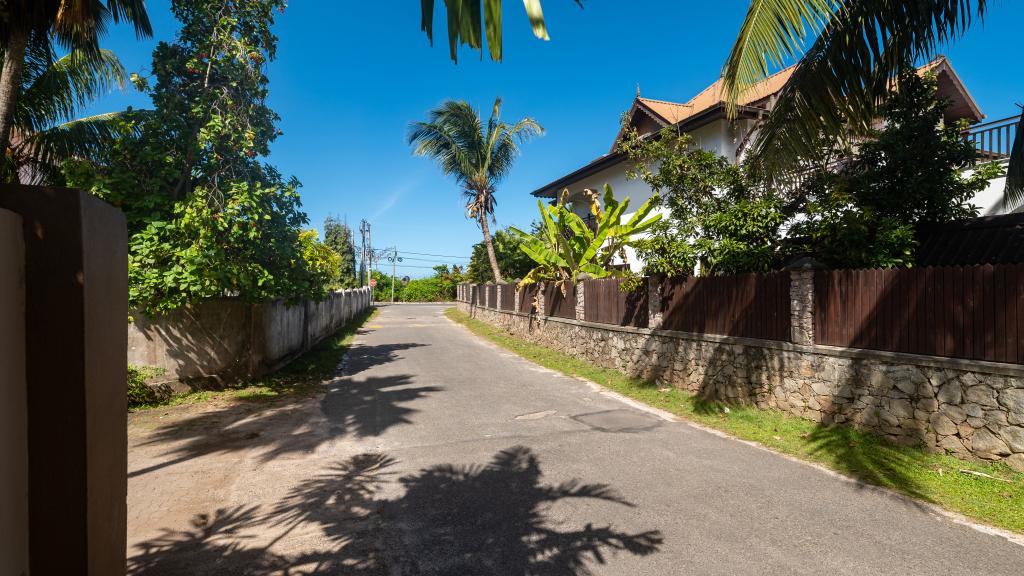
[129,305,1024,576]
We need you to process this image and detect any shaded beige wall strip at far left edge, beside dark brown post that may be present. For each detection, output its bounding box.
[0,209,29,576]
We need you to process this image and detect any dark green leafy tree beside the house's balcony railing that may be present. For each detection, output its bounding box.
[793,69,1001,268]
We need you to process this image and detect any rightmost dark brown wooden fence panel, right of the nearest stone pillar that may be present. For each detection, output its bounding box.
[814,264,1024,363]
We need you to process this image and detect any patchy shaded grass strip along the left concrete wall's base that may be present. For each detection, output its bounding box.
[130,308,378,412]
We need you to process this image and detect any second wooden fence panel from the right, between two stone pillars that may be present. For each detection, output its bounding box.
[662,272,791,341]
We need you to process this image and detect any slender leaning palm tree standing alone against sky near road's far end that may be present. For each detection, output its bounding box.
[409,98,544,282]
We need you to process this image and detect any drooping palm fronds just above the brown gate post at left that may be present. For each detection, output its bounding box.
[6,50,132,184]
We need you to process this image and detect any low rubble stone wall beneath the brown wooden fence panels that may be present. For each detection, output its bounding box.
[458,302,1024,467]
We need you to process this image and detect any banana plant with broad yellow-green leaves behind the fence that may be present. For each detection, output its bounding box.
[509,184,662,294]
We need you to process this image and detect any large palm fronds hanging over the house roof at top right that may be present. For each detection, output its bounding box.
[723,0,1024,203]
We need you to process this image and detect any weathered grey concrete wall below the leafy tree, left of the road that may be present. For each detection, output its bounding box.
[128,288,372,383]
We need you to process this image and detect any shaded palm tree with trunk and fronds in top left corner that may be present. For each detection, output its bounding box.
[0,0,153,154]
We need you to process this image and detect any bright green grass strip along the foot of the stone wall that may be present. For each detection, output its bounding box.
[445,308,1024,533]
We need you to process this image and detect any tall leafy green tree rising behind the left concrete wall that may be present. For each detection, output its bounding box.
[66,0,332,313]
